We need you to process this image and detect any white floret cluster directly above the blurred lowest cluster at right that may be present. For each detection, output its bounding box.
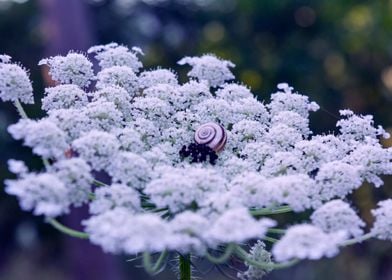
[310,199,365,237]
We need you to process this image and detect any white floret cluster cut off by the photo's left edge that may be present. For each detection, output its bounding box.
[0,59,34,104]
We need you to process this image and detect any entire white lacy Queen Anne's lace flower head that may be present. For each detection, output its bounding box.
[0,43,392,279]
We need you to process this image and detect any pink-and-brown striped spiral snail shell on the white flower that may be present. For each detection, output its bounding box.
[195,122,227,153]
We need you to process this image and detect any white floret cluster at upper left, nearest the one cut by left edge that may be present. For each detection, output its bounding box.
[38,52,94,87]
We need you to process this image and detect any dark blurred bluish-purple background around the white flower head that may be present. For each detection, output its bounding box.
[0,0,392,280]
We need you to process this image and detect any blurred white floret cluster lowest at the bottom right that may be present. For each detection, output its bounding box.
[272,224,345,262]
